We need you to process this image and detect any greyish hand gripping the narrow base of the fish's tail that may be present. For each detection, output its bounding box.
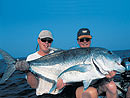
[15,60,29,71]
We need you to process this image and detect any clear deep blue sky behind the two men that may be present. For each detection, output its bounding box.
[0,0,130,57]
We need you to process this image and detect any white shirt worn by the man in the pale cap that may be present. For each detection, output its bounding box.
[26,48,58,96]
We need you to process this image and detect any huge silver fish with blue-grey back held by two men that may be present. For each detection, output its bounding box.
[0,47,125,93]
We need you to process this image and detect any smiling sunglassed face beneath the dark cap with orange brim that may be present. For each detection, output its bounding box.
[77,38,91,48]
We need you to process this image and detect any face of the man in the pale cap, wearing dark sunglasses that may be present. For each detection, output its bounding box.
[38,38,53,51]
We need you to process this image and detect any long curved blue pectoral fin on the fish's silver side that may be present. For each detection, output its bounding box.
[58,64,92,78]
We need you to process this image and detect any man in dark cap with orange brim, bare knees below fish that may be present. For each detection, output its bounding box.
[76,28,117,98]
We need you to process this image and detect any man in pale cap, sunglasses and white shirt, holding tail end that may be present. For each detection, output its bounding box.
[26,30,64,95]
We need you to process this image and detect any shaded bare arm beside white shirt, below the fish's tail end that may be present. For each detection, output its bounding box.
[27,72,38,88]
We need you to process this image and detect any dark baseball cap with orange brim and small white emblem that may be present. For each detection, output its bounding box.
[77,28,92,39]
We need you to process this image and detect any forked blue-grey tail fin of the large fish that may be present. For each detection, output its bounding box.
[0,49,16,84]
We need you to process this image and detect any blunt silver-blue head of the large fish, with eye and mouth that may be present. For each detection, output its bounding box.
[93,49,125,73]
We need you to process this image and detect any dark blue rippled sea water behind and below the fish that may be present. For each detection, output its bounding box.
[0,50,130,98]
